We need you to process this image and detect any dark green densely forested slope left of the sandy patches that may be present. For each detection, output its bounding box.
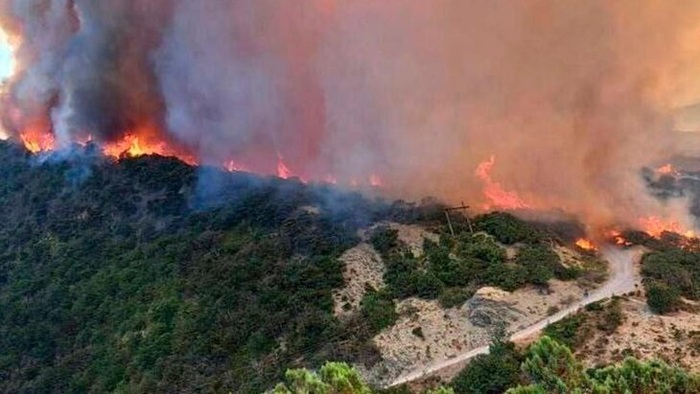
[0,143,440,392]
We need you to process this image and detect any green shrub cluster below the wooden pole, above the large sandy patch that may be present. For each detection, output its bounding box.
[380,222,580,305]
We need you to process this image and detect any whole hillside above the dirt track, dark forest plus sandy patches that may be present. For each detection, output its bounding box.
[0,142,688,393]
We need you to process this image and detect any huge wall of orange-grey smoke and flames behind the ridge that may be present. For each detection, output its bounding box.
[0,0,700,237]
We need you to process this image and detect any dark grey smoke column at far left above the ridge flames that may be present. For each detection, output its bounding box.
[2,0,171,144]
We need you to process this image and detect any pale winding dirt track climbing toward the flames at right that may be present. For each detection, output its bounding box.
[389,246,640,387]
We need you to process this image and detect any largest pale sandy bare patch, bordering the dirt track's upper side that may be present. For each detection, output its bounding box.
[367,280,583,384]
